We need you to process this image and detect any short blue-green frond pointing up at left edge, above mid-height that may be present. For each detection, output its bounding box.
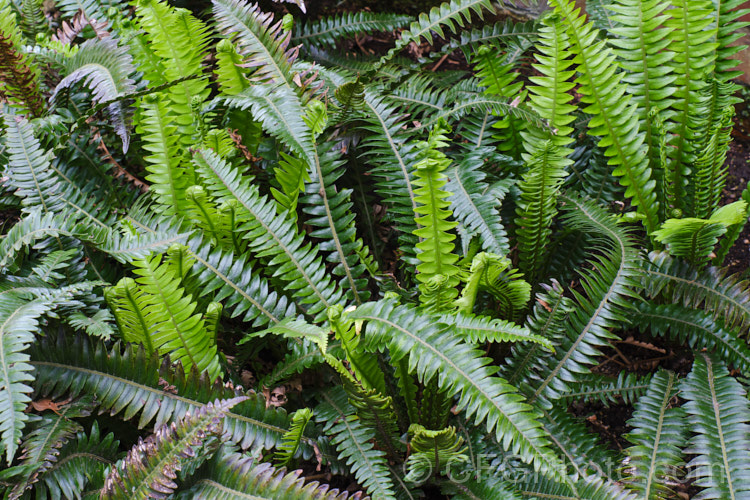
[4,114,64,213]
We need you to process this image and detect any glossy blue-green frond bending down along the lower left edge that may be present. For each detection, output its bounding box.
[0,282,98,464]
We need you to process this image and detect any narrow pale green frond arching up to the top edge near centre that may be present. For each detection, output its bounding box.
[375,0,492,69]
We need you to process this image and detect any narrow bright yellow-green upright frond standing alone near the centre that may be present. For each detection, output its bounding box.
[414,127,459,300]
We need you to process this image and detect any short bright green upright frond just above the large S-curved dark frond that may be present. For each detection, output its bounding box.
[515,140,573,283]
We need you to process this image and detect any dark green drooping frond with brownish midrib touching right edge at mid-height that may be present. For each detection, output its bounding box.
[640,252,750,329]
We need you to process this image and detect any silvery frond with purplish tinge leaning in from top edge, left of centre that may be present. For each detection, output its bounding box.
[213,0,296,90]
